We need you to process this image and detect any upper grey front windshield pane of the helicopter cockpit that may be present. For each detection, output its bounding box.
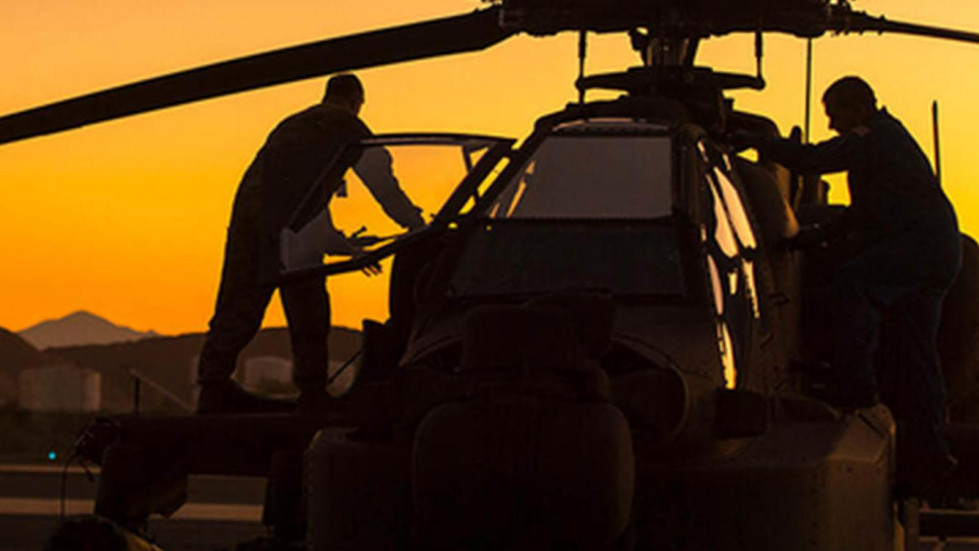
[487,134,673,219]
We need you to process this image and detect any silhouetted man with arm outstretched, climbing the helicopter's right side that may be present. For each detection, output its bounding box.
[731,76,961,487]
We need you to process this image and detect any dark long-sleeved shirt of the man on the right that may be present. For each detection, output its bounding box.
[758,109,956,241]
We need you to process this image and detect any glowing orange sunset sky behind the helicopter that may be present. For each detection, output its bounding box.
[0,0,979,333]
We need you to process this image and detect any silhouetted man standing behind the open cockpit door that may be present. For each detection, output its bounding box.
[197,74,425,414]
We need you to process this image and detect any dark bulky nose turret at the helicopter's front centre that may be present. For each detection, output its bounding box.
[411,306,635,549]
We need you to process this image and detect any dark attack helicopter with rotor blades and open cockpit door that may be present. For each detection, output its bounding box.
[9,0,979,550]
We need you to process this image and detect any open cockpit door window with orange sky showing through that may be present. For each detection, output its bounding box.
[280,135,510,273]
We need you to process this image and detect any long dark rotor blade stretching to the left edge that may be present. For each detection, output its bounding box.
[0,6,513,144]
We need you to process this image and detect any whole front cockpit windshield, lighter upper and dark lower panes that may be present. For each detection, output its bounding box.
[452,131,685,297]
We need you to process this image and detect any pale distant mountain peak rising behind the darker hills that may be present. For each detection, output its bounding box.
[18,311,158,350]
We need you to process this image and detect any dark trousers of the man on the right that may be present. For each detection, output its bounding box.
[833,218,962,453]
